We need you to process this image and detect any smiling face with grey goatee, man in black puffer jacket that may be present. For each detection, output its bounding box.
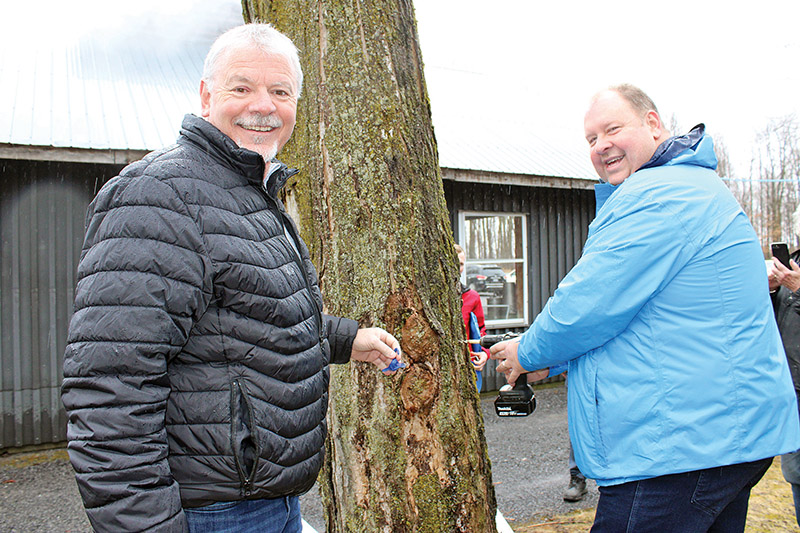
[200,47,298,161]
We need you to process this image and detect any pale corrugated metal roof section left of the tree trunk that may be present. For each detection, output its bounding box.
[0,0,242,150]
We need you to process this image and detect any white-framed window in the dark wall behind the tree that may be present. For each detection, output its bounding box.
[458,211,528,328]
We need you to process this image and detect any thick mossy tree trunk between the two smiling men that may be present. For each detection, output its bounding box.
[243,0,496,533]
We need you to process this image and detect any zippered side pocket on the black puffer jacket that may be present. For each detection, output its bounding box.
[231,379,261,498]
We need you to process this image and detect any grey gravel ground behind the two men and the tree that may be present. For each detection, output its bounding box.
[0,384,598,533]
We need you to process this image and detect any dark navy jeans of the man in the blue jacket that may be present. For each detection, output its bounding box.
[591,457,772,533]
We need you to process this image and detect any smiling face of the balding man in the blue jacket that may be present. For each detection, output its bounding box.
[583,91,666,185]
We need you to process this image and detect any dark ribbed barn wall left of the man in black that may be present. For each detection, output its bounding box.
[0,159,121,449]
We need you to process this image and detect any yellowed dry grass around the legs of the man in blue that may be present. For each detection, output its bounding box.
[513,457,800,533]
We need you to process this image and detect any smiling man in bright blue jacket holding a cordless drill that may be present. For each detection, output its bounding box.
[491,85,800,533]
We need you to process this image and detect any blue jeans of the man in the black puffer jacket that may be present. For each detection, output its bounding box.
[183,496,303,533]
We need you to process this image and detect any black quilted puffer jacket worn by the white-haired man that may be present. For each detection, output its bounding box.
[62,115,358,531]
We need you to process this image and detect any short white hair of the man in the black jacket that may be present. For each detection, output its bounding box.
[203,22,303,98]
